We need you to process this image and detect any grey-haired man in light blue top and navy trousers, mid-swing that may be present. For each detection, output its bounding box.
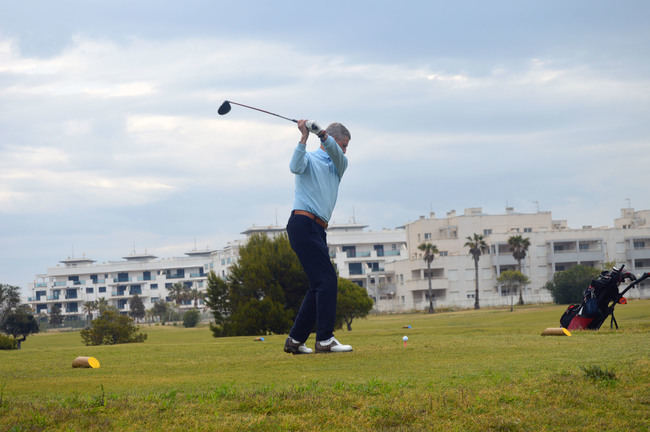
[284,120,352,354]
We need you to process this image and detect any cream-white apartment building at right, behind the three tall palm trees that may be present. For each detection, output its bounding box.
[380,208,650,312]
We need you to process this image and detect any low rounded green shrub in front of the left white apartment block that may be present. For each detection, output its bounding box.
[81,310,147,345]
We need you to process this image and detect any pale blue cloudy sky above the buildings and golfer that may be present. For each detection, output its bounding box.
[0,0,650,292]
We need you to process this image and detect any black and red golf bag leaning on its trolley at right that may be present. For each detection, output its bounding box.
[560,265,650,330]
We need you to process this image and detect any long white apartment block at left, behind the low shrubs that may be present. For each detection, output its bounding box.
[28,243,240,320]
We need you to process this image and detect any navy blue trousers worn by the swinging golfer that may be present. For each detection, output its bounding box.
[287,214,338,342]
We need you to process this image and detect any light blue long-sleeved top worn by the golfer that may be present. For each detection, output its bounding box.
[289,136,348,222]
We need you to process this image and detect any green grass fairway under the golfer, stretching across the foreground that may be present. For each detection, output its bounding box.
[0,301,650,432]
